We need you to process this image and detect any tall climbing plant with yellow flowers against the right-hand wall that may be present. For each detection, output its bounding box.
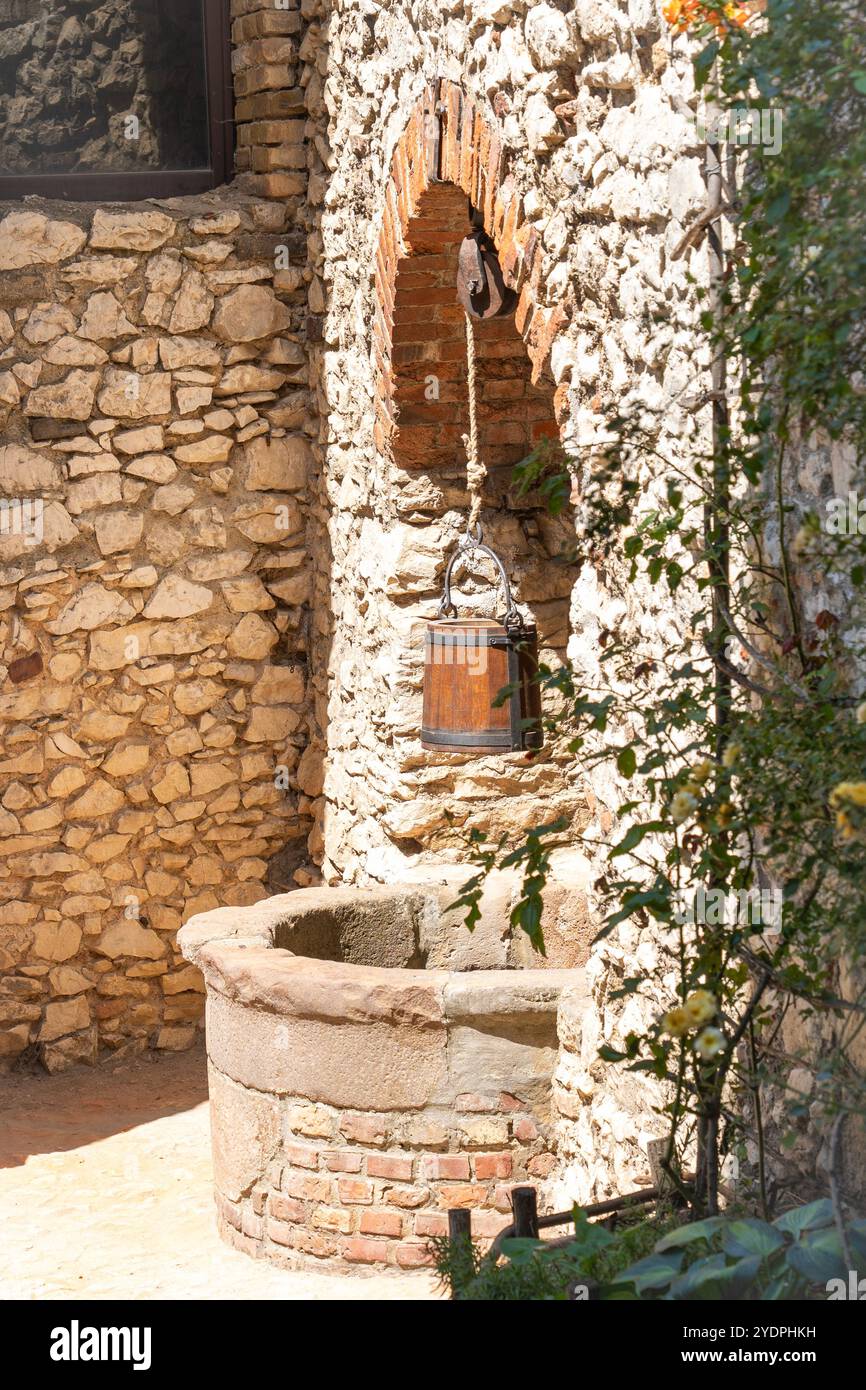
[460,0,866,1217]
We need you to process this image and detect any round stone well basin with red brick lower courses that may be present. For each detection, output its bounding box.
[179,887,582,1269]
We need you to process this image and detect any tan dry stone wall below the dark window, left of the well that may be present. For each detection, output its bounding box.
[0,190,313,1070]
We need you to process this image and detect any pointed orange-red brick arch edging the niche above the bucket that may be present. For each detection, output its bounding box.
[374,79,566,461]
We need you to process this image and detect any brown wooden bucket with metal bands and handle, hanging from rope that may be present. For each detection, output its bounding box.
[421,542,542,753]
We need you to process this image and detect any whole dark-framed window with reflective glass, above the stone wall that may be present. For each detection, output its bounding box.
[0,0,234,202]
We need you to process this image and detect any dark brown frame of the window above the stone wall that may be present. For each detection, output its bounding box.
[0,0,235,203]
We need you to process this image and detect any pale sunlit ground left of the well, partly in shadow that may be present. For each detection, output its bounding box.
[0,1051,438,1301]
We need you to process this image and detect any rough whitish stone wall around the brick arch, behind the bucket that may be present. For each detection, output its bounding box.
[316,0,706,1200]
